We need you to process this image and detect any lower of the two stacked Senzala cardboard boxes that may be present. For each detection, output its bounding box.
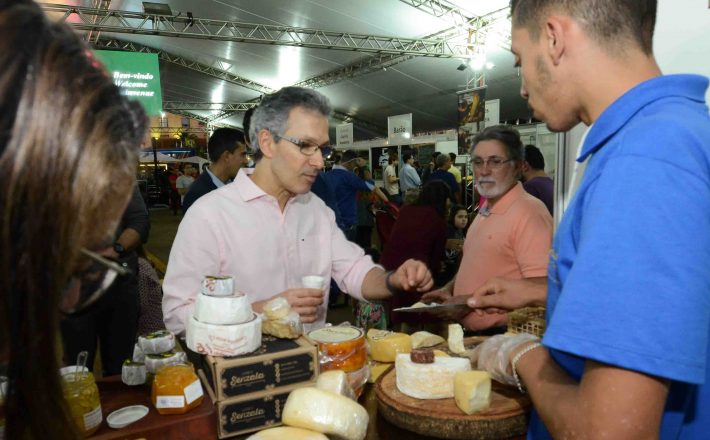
[198,370,315,440]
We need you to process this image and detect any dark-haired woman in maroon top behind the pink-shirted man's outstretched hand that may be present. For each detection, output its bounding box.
[380,180,450,324]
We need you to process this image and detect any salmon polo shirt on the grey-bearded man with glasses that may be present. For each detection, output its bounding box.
[454,183,552,295]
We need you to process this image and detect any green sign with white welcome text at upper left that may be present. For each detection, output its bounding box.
[94,50,163,116]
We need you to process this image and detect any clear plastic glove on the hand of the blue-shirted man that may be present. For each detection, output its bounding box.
[471,333,540,385]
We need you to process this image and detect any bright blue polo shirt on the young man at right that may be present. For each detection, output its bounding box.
[528,75,710,439]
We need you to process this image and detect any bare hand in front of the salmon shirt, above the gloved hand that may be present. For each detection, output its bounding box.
[468,277,547,316]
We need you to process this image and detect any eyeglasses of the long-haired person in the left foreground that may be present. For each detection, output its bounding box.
[59,248,132,315]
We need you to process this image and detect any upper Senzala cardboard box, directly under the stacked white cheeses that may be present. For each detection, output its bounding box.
[205,335,318,401]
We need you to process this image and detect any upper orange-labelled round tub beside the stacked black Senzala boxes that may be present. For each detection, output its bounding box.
[308,326,367,373]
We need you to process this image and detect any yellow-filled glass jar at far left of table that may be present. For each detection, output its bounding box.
[62,371,103,437]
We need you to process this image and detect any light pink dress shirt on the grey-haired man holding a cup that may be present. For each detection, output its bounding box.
[163,169,379,334]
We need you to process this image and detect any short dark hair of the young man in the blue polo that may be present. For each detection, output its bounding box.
[510,0,658,54]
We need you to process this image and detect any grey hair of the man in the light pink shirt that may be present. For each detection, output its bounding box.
[249,87,332,155]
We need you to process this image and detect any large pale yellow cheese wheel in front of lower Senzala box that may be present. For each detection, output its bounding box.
[281,387,369,440]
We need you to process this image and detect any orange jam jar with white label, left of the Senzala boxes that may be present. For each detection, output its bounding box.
[151,363,204,414]
